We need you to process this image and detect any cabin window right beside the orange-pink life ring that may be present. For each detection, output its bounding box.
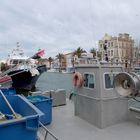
[84,73,95,88]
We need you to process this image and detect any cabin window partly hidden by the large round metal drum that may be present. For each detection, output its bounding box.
[104,72,117,89]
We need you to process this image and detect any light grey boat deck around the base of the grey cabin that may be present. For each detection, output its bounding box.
[39,100,140,140]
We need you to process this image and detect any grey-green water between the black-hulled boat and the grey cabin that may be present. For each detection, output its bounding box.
[36,72,73,93]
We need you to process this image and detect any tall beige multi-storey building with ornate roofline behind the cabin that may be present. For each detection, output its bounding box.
[98,33,138,66]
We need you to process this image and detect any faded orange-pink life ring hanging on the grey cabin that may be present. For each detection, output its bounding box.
[72,72,83,87]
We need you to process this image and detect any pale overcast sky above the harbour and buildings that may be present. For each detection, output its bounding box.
[0,0,140,58]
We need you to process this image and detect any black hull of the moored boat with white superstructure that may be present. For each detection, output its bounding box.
[8,65,46,90]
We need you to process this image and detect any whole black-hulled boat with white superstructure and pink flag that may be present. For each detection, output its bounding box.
[2,43,46,90]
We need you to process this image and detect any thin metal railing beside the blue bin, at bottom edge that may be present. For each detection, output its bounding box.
[37,122,58,140]
